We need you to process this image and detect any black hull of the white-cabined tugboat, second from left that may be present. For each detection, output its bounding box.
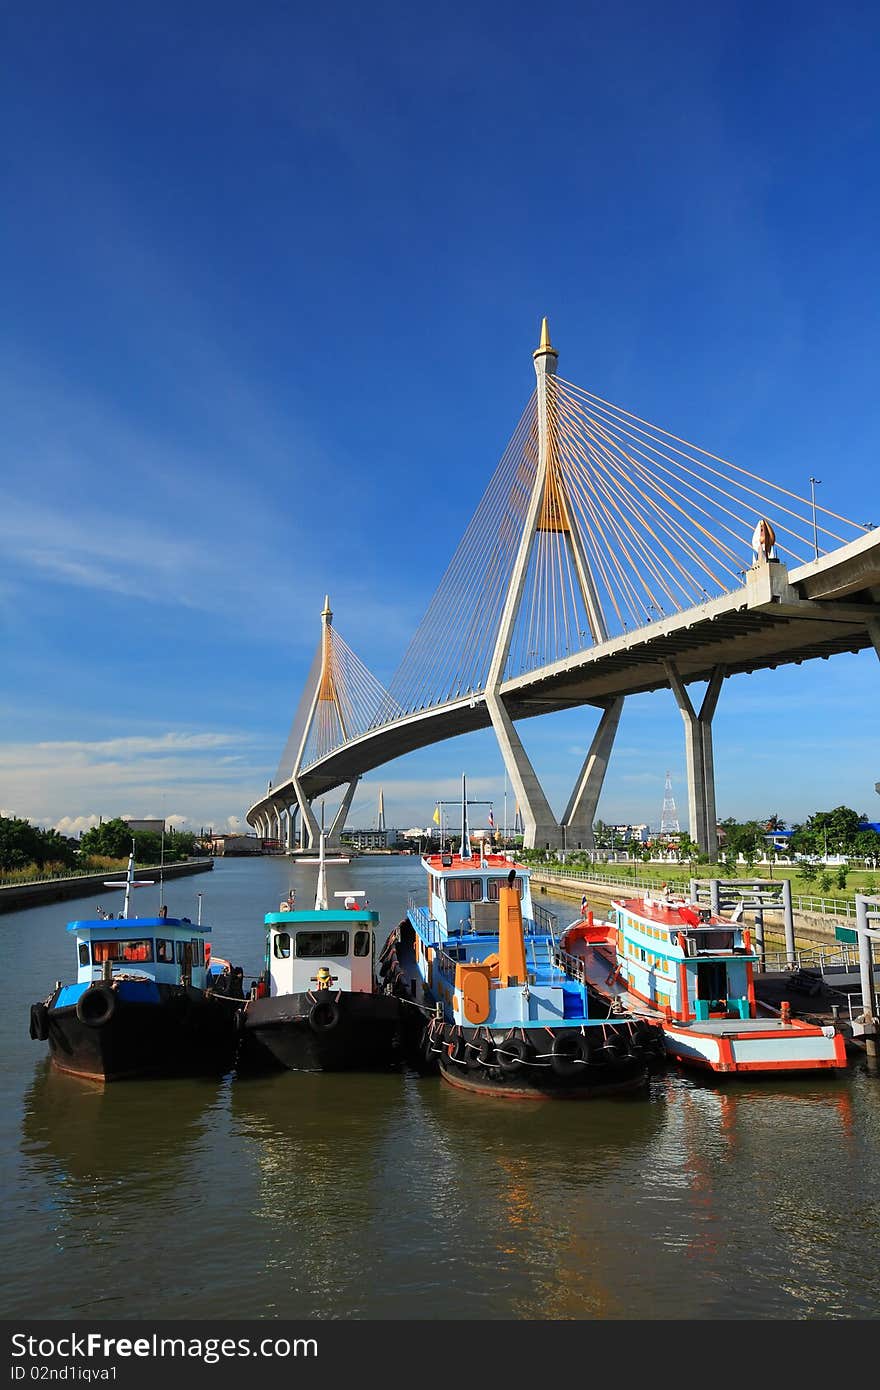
[236,991,403,1072]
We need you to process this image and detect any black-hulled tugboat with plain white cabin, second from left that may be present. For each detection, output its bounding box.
[236,831,403,1073]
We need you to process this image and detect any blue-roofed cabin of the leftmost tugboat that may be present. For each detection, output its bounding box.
[67,917,211,990]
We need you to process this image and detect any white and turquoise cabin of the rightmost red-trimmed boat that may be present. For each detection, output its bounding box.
[609,895,758,1022]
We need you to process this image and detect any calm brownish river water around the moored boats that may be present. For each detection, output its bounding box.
[0,856,880,1319]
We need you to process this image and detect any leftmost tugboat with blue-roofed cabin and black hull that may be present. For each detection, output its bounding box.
[31,849,241,1081]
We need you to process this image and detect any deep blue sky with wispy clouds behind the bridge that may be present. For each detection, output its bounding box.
[0,0,880,828]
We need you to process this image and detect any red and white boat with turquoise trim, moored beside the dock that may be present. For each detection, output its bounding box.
[562,894,847,1074]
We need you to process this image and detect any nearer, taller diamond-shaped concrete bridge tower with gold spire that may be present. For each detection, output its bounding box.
[485,318,623,851]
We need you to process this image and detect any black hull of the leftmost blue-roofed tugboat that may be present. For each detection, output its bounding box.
[32,984,236,1081]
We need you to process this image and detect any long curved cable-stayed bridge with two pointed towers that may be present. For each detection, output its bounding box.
[247,320,880,853]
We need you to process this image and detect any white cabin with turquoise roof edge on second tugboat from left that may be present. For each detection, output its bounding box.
[264,908,380,995]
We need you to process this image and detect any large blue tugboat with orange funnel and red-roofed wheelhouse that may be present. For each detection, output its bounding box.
[382,795,656,1099]
